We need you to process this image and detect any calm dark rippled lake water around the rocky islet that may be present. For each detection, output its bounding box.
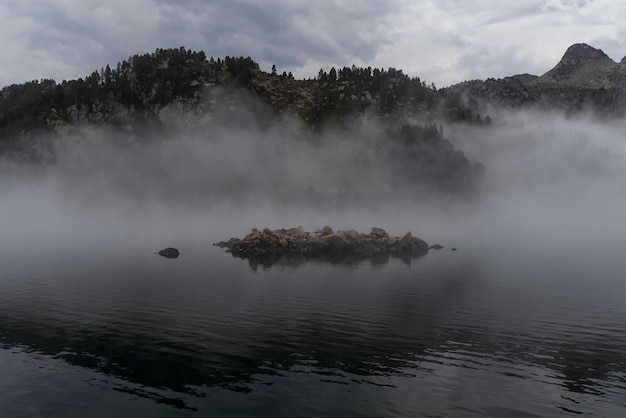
[0,230,626,417]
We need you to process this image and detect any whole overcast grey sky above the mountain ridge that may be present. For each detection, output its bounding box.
[0,0,626,87]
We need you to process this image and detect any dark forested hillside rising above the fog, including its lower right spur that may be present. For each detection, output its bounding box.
[0,47,490,200]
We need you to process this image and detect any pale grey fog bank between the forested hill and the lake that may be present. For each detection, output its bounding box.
[0,102,626,262]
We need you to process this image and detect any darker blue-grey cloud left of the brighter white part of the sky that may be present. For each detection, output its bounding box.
[0,0,399,85]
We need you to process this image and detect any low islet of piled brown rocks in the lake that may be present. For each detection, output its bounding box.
[214,226,429,257]
